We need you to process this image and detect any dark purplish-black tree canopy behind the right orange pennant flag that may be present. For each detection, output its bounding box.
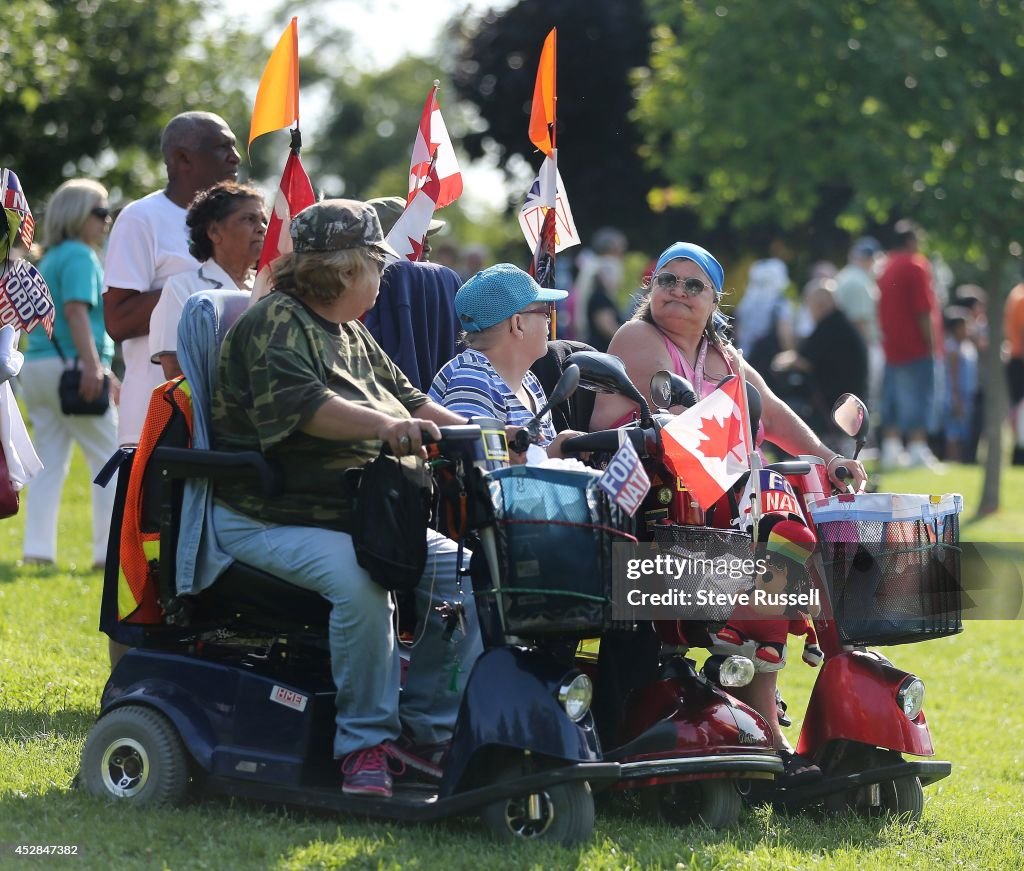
[453,0,692,248]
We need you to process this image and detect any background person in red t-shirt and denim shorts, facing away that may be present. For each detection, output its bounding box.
[879,220,943,470]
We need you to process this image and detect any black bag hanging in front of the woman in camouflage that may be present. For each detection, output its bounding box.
[352,446,432,591]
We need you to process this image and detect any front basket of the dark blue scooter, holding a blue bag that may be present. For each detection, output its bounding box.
[477,466,636,638]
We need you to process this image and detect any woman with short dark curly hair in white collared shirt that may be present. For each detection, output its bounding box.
[150,181,267,379]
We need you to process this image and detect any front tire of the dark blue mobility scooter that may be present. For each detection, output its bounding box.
[480,766,594,846]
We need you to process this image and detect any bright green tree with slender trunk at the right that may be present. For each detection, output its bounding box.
[636,0,1024,513]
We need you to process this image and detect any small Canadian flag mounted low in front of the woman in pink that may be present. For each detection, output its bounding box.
[662,377,751,511]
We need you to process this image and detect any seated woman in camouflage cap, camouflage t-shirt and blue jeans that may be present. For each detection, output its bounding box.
[213,200,480,796]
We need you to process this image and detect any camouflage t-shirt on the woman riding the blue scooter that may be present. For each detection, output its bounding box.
[212,293,427,532]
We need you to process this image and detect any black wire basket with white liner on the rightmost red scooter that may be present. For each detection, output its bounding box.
[811,493,964,645]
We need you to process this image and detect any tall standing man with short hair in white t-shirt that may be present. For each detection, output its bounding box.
[103,112,240,444]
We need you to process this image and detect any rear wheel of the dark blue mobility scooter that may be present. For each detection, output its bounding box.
[79,704,188,808]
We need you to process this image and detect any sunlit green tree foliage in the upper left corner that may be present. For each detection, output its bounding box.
[0,0,249,204]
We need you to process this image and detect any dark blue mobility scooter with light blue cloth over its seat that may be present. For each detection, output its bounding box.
[78,291,625,844]
